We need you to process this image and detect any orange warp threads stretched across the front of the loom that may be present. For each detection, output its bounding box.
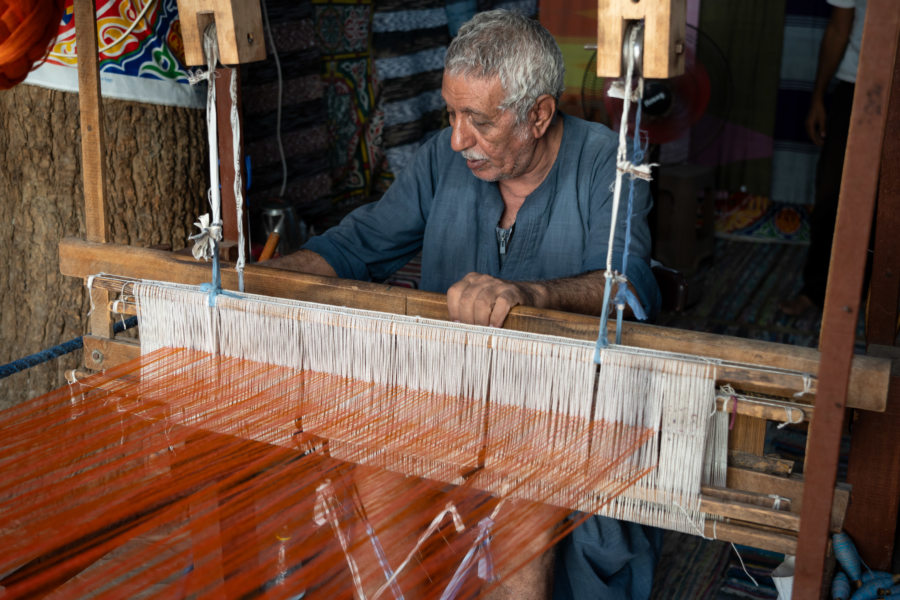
[0,348,652,600]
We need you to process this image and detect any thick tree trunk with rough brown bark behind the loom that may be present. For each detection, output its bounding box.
[0,85,208,407]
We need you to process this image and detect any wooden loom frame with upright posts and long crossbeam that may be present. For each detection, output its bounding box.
[8,0,897,597]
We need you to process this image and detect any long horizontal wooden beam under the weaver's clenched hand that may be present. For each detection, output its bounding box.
[60,238,890,410]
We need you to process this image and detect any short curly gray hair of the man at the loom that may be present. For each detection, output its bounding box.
[444,9,566,123]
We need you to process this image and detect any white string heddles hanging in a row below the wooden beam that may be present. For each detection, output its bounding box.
[134,283,715,532]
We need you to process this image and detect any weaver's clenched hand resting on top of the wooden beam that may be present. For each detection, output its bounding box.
[447,273,546,327]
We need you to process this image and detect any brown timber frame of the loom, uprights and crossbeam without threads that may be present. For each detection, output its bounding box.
[59,0,900,598]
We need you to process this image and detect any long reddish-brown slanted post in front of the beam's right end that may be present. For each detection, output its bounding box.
[793,0,900,600]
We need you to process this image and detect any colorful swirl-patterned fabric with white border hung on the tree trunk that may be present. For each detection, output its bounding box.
[25,0,206,108]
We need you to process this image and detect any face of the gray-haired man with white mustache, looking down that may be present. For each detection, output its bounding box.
[441,73,535,181]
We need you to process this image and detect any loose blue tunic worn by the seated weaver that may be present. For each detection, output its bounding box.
[304,115,660,600]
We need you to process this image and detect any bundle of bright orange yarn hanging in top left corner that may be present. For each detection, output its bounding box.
[0,0,65,90]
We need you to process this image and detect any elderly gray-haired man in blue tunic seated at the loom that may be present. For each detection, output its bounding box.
[275,10,659,598]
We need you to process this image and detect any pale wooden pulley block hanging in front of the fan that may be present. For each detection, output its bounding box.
[597,0,687,79]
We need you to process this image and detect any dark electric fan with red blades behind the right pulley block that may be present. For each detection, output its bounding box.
[581,25,732,162]
